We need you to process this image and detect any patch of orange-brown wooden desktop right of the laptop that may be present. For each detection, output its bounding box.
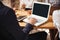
[38,15,55,29]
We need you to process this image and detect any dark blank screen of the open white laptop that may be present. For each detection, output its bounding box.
[32,3,49,18]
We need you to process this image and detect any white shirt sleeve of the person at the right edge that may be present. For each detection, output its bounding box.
[53,10,60,32]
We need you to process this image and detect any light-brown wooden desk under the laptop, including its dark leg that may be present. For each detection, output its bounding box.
[15,11,56,40]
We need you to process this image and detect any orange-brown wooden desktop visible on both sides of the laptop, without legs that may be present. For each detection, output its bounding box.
[15,11,55,29]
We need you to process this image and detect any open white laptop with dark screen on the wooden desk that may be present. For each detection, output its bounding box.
[23,2,51,26]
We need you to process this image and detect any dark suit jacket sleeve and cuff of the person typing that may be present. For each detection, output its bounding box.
[1,9,31,40]
